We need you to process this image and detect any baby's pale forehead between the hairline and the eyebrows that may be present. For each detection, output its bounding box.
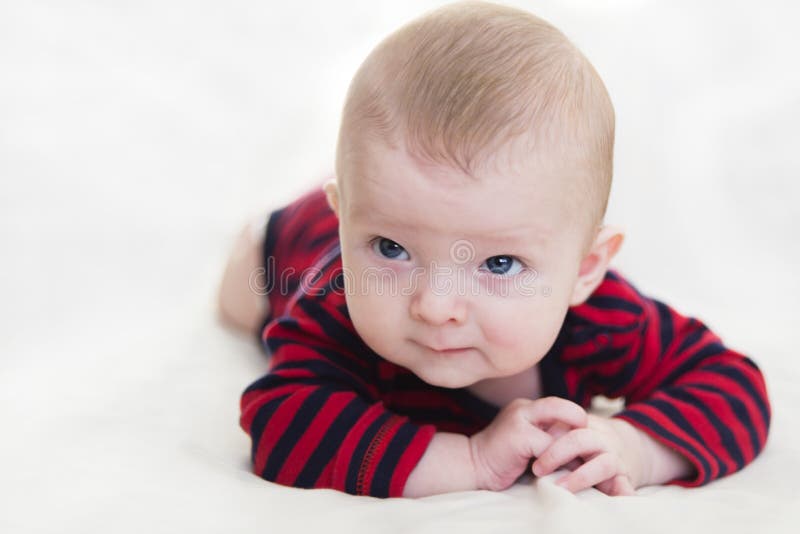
[344,144,580,242]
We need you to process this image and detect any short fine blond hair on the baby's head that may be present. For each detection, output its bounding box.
[336,2,614,252]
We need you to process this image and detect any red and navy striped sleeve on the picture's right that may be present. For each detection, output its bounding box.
[573,271,771,487]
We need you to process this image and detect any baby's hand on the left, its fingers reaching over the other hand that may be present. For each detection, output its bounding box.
[469,397,587,491]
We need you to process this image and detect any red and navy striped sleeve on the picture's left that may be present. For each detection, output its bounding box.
[240,253,436,497]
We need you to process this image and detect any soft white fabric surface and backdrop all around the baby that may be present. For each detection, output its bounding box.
[0,0,800,533]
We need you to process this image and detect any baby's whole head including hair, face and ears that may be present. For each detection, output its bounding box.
[326,2,622,388]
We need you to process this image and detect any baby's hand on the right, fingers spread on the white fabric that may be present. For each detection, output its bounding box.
[532,414,643,495]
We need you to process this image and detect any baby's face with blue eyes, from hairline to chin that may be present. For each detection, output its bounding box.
[330,139,583,388]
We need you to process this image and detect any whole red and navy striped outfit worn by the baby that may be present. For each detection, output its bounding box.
[240,183,771,497]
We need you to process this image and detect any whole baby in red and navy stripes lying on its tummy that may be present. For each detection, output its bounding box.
[220,2,771,497]
